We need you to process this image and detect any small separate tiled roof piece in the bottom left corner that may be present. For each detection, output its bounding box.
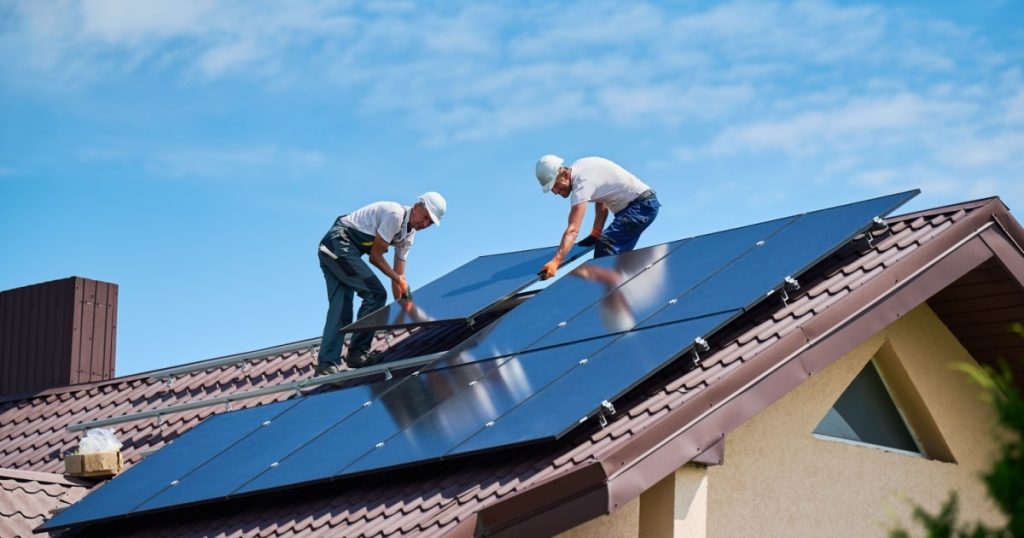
[0,468,88,538]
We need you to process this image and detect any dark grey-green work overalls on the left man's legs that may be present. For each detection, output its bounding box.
[316,217,387,365]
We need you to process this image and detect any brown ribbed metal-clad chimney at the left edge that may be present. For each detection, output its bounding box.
[0,277,118,395]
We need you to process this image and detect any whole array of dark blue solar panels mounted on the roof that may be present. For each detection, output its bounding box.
[43,192,916,530]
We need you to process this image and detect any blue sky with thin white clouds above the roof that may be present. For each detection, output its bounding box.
[0,0,1024,374]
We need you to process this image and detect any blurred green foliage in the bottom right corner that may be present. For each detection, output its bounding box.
[889,348,1024,538]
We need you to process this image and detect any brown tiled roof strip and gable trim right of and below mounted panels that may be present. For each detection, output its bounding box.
[8,199,1024,536]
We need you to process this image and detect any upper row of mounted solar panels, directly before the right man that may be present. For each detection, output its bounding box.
[426,191,918,369]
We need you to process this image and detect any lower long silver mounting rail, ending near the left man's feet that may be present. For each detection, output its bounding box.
[65,351,444,431]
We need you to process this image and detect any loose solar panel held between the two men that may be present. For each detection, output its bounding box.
[342,243,590,332]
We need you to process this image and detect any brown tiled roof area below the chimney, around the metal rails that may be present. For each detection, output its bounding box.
[0,320,488,472]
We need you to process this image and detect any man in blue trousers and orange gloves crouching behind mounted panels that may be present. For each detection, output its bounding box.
[537,155,662,280]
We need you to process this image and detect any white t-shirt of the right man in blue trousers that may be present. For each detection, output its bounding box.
[569,157,650,213]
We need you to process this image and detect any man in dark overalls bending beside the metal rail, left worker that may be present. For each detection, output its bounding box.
[316,192,447,375]
